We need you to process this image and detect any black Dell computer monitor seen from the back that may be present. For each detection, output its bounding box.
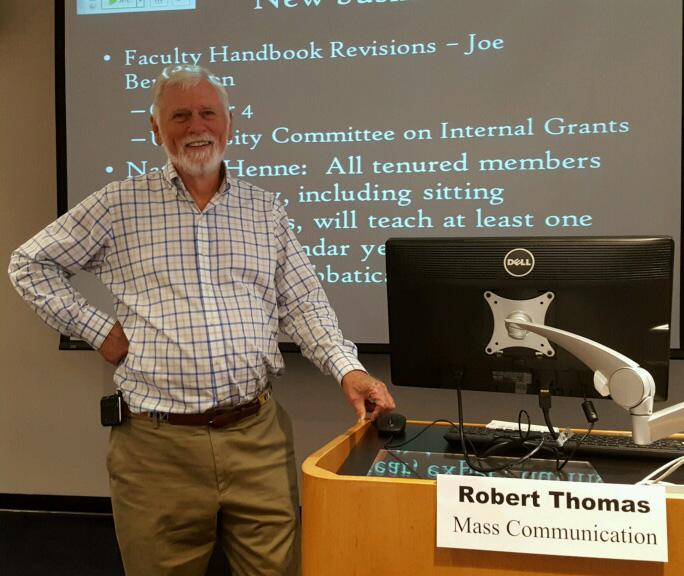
[386,237,674,400]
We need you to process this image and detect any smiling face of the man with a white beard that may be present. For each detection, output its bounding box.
[152,80,233,177]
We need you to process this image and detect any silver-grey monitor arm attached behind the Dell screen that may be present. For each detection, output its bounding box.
[505,317,684,444]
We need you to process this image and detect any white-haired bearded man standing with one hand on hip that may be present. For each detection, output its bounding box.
[10,67,394,576]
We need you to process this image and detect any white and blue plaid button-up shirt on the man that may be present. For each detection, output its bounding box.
[9,163,363,413]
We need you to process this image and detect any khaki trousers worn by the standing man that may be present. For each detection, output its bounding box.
[107,399,299,576]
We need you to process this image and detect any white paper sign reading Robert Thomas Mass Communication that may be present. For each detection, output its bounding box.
[437,475,667,562]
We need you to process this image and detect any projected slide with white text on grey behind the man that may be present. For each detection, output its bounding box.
[65,0,682,347]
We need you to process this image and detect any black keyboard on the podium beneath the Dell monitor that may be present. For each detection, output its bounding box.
[444,426,684,460]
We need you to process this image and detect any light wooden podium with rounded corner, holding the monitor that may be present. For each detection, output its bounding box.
[302,423,684,576]
